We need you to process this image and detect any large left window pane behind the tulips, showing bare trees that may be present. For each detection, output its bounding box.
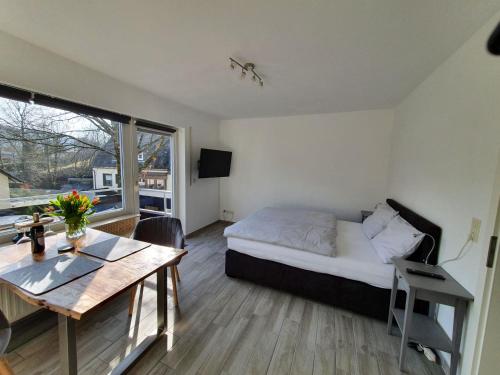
[0,98,122,229]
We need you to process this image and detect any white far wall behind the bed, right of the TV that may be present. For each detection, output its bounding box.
[220,110,393,220]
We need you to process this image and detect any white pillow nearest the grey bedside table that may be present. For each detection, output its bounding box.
[370,216,425,263]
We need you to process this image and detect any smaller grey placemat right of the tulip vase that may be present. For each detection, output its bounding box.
[80,236,151,262]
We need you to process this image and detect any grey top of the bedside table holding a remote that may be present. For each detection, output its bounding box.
[394,258,474,301]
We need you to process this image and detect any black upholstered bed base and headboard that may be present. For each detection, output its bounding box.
[226,199,441,320]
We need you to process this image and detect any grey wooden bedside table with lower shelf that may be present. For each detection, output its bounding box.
[387,258,474,375]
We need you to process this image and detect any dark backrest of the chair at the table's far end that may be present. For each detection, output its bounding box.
[133,216,184,249]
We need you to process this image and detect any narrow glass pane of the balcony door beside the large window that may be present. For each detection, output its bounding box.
[137,130,172,218]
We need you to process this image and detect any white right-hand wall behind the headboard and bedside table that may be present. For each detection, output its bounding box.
[389,13,500,375]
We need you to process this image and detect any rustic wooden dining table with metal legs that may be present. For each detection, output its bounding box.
[0,229,187,375]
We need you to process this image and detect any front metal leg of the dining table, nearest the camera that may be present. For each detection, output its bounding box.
[58,314,78,375]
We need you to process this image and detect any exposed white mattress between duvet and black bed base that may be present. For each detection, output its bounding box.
[227,220,394,289]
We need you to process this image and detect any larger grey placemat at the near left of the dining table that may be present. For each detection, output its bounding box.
[0,255,103,295]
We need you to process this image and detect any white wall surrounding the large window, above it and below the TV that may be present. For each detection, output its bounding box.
[0,32,219,232]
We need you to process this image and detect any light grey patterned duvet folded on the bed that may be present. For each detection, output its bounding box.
[224,207,337,256]
